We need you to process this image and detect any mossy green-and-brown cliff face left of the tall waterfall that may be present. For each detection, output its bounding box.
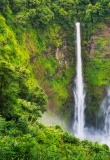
[24,26,75,118]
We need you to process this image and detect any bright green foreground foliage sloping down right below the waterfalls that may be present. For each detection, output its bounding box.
[0,118,110,160]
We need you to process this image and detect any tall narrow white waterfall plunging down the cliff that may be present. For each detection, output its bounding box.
[73,22,85,139]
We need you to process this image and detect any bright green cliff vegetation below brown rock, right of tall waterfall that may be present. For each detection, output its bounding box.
[86,59,110,86]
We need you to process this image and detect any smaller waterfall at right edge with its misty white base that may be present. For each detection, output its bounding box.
[85,88,110,147]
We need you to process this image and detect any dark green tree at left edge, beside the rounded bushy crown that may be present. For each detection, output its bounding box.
[0,61,18,118]
